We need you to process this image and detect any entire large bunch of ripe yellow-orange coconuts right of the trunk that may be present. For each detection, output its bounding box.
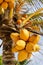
[10,28,40,62]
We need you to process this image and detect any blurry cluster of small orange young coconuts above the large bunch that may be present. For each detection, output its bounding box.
[16,14,40,32]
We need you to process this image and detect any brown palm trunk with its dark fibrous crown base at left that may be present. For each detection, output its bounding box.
[0,10,14,65]
